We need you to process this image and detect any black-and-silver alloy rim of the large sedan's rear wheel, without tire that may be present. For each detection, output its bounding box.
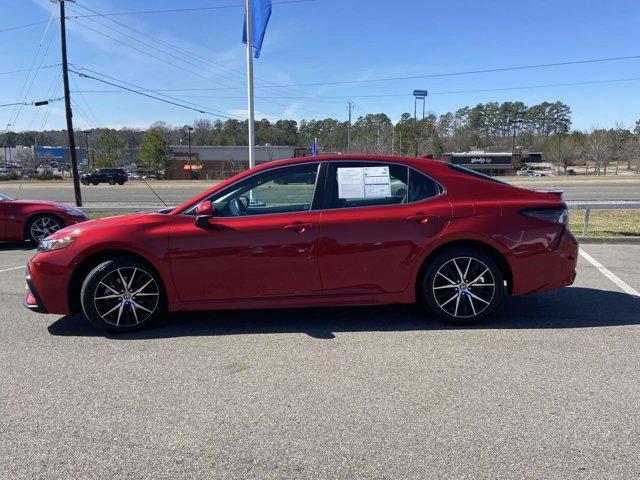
[431,257,496,318]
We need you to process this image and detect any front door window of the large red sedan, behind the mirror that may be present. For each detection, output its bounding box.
[211,163,319,217]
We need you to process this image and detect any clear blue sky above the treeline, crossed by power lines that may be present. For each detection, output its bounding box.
[0,0,640,130]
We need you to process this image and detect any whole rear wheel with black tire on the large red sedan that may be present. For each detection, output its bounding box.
[420,247,504,325]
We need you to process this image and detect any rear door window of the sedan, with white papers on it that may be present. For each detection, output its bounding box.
[323,162,409,208]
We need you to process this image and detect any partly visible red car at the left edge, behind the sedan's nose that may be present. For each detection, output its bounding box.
[0,194,87,243]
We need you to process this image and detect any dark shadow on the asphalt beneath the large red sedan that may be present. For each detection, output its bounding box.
[49,287,640,340]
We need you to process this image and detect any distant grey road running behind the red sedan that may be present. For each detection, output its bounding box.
[0,175,640,207]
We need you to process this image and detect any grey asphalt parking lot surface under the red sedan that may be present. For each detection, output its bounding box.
[0,245,640,479]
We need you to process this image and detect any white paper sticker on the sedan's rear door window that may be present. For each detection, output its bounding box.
[338,166,391,200]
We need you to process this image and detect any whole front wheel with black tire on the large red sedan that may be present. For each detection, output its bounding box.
[80,256,166,333]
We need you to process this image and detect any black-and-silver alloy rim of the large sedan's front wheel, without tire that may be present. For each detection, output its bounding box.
[93,267,160,327]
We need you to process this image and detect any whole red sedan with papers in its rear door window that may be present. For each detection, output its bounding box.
[25,155,578,332]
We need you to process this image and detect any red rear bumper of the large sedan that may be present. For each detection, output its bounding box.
[510,228,579,295]
